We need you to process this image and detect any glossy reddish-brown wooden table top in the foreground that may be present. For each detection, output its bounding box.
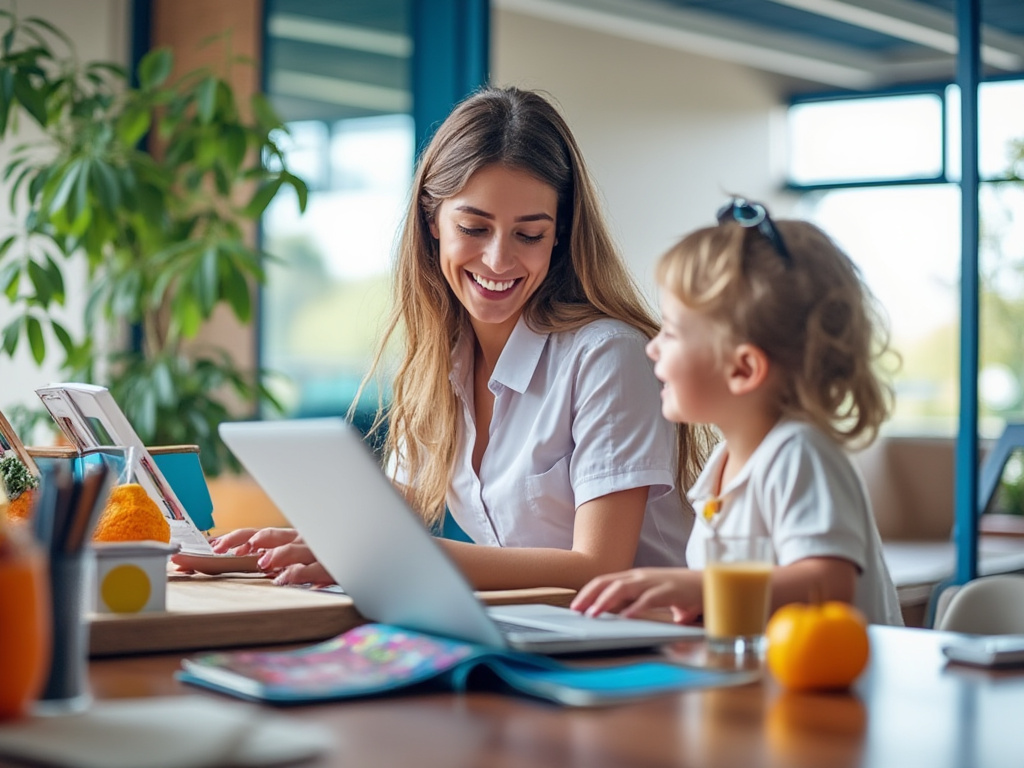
[72,627,1024,768]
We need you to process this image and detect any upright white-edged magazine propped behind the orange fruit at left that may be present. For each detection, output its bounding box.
[36,383,213,554]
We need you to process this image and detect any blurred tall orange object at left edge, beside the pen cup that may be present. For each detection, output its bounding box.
[0,521,50,720]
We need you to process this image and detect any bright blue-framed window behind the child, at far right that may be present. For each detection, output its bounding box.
[790,80,1024,436]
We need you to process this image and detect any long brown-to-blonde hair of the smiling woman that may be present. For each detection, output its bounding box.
[365,88,710,525]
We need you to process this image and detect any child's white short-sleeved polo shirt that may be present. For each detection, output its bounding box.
[686,420,903,626]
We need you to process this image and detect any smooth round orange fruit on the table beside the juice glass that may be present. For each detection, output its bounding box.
[766,601,869,690]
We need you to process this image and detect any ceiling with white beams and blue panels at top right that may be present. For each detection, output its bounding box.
[494,0,1024,90]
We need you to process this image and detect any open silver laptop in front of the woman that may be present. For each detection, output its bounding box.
[220,419,703,653]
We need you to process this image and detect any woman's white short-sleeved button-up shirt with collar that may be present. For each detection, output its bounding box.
[447,317,692,565]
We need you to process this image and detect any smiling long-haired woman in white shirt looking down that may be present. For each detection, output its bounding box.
[209,88,709,589]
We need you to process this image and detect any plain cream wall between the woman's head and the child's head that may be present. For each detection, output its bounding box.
[492,8,788,298]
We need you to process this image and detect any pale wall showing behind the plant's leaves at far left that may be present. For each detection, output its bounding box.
[0,0,128,421]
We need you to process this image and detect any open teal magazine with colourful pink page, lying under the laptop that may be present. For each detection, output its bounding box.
[177,624,758,707]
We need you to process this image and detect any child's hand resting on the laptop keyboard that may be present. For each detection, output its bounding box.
[570,568,703,624]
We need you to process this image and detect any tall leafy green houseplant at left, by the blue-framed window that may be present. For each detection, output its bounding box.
[0,10,306,475]
